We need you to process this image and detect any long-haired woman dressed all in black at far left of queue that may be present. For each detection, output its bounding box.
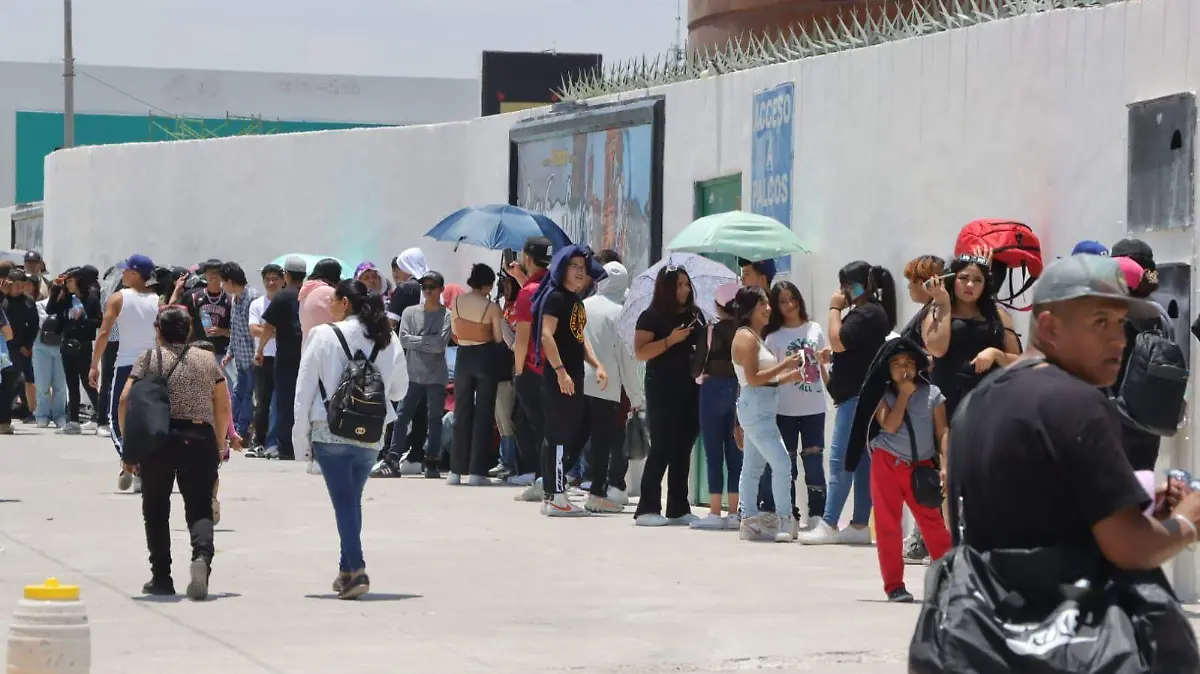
[46,265,104,435]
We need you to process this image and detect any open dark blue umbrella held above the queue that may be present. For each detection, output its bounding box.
[425,204,571,251]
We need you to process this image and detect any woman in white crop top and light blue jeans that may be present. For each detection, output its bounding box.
[724,287,803,543]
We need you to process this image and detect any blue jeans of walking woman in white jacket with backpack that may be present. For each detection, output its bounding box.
[312,443,378,572]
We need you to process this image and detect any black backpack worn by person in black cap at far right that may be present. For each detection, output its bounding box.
[1116,330,1189,438]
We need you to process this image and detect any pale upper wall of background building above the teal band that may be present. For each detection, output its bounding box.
[0,62,480,205]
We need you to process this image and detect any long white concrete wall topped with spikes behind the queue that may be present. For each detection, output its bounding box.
[46,0,1200,587]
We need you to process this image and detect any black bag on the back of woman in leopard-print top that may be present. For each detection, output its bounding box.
[122,347,191,465]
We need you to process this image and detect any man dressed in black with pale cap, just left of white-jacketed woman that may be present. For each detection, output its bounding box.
[254,255,308,461]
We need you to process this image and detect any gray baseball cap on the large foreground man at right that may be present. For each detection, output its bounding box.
[1033,254,1159,319]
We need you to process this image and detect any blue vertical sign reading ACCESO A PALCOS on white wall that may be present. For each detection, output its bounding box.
[750,82,796,273]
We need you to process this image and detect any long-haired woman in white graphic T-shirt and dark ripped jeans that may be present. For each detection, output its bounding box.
[758,281,829,526]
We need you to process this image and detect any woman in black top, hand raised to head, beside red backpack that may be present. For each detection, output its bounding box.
[922,253,1021,419]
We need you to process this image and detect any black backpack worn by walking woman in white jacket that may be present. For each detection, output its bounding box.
[317,325,388,443]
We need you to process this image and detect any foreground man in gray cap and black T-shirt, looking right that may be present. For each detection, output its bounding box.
[947,254,1200,570]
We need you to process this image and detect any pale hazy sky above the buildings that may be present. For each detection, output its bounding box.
[0,0,688,78]
